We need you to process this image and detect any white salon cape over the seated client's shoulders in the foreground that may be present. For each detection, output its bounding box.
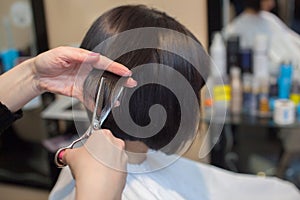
[49,151,300,200]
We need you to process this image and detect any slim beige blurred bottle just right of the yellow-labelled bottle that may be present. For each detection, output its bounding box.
[230,67,243,115]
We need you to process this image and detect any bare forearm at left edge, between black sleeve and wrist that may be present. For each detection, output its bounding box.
[0,59,41,112]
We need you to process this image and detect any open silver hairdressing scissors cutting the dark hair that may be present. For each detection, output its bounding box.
[54,76,124,168]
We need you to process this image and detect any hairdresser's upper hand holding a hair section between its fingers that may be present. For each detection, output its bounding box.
[33,47,131,100]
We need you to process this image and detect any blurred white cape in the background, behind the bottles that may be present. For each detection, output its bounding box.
[223,11,300,73]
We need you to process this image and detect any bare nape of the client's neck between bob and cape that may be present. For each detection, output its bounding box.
[125,141,149,164]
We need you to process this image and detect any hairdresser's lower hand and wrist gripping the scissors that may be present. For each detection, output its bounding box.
[63,130,127,199]
